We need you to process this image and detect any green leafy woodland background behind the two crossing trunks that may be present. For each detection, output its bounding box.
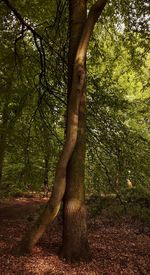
[0,0,150,274]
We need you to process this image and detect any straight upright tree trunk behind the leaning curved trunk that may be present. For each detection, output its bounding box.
[61,0,90,262]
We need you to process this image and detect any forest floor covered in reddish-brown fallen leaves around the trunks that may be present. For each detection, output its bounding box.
[0,198,150,275]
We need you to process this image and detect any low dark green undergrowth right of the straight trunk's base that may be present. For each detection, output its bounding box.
[87,184,150,225]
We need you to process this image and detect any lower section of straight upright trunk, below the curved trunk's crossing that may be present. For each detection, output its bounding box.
[61,91,90,262]
